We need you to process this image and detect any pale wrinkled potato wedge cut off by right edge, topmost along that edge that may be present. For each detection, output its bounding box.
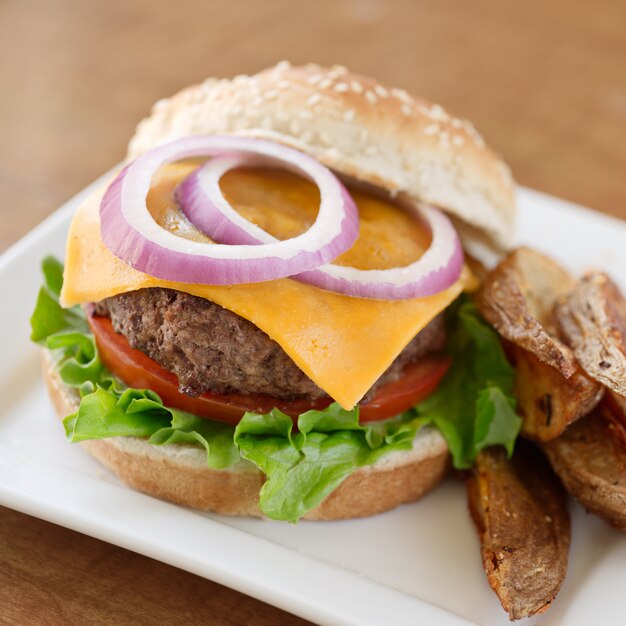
[556,272,626,396]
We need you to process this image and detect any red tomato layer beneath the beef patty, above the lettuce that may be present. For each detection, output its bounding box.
[87,315,450,424]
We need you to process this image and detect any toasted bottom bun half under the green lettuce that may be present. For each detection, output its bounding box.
[42,350,448,520]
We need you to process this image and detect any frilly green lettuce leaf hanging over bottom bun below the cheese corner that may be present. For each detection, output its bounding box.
[235,404,422,522]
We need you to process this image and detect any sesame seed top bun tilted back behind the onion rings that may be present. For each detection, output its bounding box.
[128,62,515,249]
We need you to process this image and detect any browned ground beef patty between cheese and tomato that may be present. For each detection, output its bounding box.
[95,287,446,400]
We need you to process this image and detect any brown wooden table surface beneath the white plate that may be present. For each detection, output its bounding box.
[0,0,626,624]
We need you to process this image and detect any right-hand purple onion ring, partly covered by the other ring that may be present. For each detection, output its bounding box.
[177,155,464,300]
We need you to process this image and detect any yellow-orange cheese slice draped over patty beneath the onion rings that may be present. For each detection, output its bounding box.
[61,164,475,408]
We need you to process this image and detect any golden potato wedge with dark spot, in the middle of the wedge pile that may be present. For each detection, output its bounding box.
[512,346,604,442]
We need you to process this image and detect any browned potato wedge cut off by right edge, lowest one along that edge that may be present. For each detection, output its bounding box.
[543,402,626,531]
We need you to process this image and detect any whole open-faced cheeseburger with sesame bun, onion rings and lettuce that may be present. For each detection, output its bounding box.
[31,63,520,522]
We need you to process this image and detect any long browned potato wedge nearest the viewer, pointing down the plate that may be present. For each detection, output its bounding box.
[467,441,570,620]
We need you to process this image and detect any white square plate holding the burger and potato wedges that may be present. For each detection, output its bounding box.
[0,177,626,626]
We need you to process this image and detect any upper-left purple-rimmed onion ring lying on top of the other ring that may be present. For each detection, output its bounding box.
[100,136,358,285]
